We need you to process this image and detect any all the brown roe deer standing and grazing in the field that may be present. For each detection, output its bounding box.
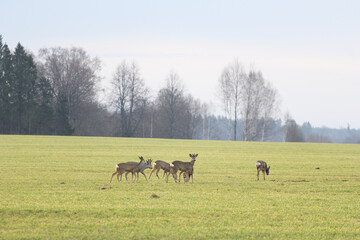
[110,153,270,183]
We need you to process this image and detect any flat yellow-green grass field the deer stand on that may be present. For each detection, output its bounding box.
[0,136,360,239]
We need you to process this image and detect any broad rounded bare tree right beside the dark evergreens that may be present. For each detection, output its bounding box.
[38,47,100,135]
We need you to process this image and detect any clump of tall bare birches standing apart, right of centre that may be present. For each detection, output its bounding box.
[219,60,278,141]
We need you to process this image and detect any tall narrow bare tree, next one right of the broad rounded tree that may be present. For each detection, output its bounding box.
[112,60,148,137]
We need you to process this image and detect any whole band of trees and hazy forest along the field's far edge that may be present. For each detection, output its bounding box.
[0,35,360,143]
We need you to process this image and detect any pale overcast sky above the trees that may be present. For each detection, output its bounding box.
[0,0,360,128]
